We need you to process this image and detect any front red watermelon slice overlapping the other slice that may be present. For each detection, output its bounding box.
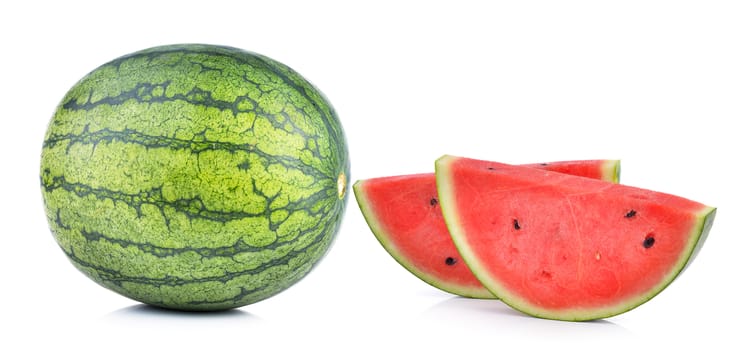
[436,156,716,321]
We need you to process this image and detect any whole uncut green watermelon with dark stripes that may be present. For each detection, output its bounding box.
[40,44,349,310]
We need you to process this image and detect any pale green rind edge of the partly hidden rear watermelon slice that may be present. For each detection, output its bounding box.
[353,180,496,299]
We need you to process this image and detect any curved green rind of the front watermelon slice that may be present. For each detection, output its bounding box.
[435,155,716,321]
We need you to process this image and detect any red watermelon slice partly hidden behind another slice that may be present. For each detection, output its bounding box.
[353,160,619,298]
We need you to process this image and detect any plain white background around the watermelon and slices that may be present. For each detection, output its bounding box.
[0,0,748,349]
